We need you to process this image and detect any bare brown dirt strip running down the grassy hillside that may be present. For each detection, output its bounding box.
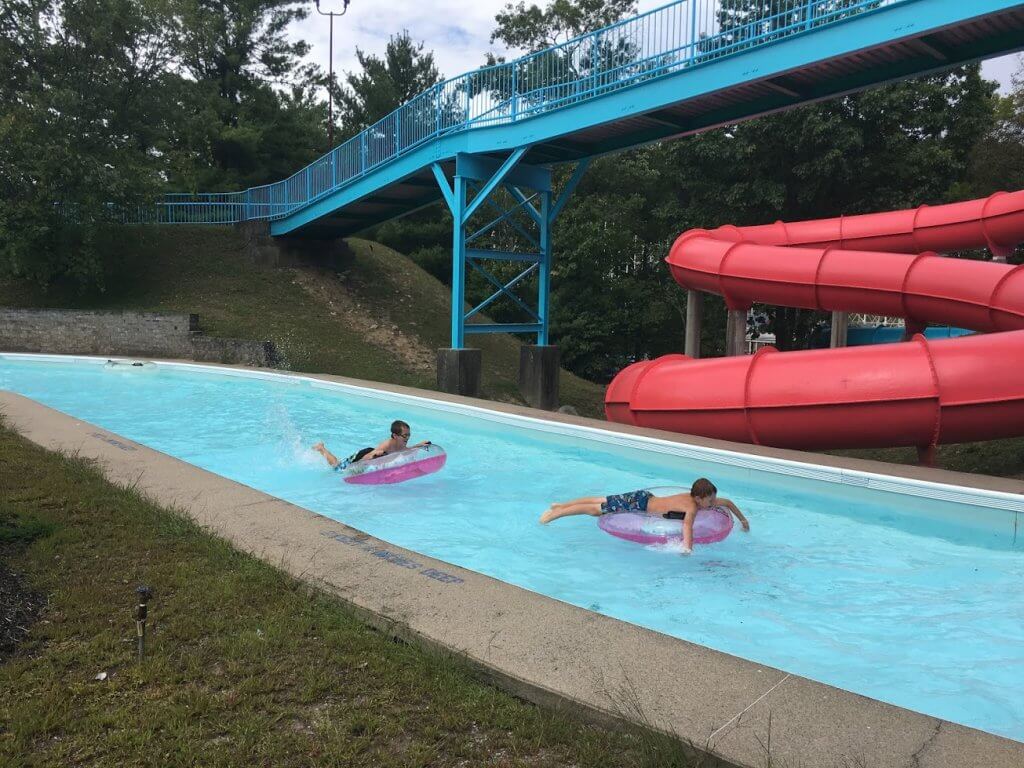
[292,268,437,376]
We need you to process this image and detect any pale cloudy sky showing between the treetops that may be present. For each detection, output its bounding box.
[293,0,1021,92]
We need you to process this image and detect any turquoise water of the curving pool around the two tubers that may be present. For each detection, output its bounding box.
[0,355,1024,740]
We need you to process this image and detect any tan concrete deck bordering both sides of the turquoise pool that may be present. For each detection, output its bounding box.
[0,362,1024,768]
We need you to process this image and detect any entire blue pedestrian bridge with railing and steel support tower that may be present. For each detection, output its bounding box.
[141,0,1024,348]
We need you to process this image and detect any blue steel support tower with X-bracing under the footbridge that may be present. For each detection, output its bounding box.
[431,147,589,349]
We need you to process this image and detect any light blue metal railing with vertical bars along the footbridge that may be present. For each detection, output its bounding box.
[146,0,913,224]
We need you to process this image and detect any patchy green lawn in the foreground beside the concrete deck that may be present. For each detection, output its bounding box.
[0,427,710,768]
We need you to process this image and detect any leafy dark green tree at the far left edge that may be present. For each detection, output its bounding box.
[0,0,170,285]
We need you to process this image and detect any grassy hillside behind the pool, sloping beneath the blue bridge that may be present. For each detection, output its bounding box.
[0,226,604,416]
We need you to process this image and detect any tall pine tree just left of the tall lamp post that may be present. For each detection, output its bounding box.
[162,0,326,191]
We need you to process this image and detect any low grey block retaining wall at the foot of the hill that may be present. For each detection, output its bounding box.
[0,307,276,367]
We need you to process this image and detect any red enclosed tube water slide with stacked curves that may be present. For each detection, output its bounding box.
[605,191,1024,451]
